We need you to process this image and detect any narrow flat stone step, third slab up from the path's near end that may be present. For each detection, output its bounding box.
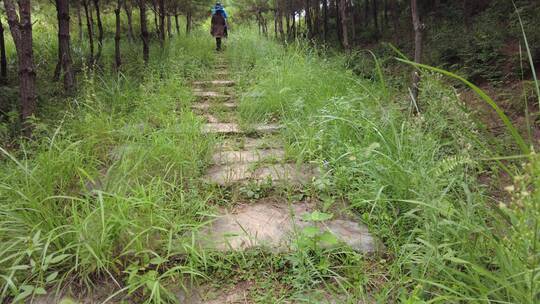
[212,149,285,165]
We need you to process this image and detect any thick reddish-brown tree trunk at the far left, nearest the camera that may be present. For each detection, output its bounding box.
[4,0,36,129]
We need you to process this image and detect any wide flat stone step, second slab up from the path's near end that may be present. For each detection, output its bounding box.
[205,163,319,186]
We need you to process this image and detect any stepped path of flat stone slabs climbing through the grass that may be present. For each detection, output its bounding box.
[192,56,378,253]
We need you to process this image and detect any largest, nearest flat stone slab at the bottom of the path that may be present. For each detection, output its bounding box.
[197,203,381,253]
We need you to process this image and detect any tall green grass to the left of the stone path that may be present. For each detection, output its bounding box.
[0,26,217,303]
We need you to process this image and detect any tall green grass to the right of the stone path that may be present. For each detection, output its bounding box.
[228,27,540,303]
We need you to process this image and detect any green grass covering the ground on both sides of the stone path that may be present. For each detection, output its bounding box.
[0,8,540,303]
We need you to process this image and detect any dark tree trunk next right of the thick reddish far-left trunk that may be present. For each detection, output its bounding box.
[54,0,75,92]
